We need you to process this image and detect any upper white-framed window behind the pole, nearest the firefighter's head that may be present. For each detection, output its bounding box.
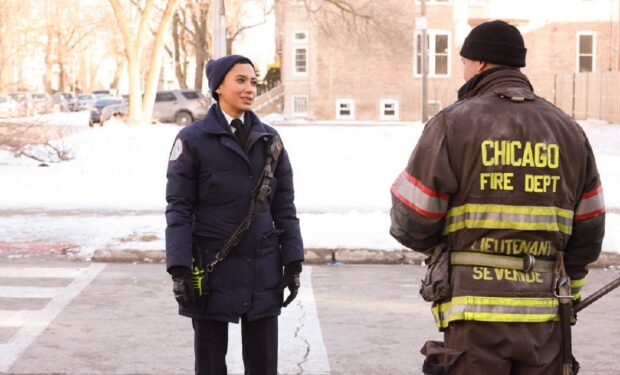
[415,30,450,77]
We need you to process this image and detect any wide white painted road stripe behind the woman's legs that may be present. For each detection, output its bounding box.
[226,267,330,375]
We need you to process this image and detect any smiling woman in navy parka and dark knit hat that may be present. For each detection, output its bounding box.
[166,55,304,375]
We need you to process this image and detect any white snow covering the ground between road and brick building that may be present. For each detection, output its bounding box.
[0,112,620,257]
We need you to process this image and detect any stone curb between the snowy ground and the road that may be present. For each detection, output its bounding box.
[91,249,620,268]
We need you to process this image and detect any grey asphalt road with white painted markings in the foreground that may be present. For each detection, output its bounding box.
[0,256,620,375]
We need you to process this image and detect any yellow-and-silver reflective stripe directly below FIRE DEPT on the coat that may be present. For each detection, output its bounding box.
[443,203,573,235]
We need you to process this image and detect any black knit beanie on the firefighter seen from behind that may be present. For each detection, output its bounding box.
[461,20,527,68]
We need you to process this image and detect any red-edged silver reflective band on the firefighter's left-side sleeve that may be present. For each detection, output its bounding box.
[391,171,448,219]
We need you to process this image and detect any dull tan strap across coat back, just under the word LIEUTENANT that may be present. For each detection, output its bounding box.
[450,251,555,272]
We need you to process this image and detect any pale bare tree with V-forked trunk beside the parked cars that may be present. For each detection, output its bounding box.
[109,0,177,124]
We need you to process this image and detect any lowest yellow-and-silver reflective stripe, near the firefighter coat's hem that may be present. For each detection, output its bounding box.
[432,296,559,329]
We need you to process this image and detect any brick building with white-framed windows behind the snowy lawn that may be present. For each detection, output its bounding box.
[276,0,620,122]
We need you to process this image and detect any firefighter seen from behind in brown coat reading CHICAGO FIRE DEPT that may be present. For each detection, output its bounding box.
[390,20,605,375]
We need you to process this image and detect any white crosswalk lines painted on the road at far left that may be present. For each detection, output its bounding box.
[0,263,106,372]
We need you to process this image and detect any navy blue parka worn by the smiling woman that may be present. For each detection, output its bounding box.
[166,103,304,322]
